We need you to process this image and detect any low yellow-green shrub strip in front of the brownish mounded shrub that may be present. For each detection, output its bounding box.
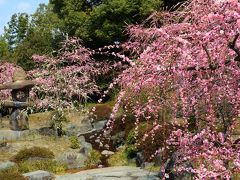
[18,160,67,173]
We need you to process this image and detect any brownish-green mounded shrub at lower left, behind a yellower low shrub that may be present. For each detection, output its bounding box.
[12,147,54,162]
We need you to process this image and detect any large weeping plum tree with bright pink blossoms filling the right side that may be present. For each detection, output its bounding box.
[105,0,240,179]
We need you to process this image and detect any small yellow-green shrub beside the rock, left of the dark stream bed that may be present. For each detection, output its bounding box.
[85,150,101,168]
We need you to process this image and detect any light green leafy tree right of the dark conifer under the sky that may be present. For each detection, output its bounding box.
[13,4,64,70]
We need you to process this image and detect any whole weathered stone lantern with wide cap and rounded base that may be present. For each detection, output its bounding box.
[0,68,35,131]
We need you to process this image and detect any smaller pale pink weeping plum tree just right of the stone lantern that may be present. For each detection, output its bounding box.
[29,39,100,109]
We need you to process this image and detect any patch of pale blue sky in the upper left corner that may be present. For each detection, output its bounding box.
[0,0,48,34]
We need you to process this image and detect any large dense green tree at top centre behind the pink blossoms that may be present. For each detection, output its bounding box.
[50,0,163,48]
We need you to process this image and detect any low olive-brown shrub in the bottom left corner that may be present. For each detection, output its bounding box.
[0,167,27,180]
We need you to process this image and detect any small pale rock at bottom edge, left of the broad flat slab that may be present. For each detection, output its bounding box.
[23,170,54,180]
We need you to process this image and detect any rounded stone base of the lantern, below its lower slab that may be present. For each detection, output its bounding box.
[10,109,29,131]
